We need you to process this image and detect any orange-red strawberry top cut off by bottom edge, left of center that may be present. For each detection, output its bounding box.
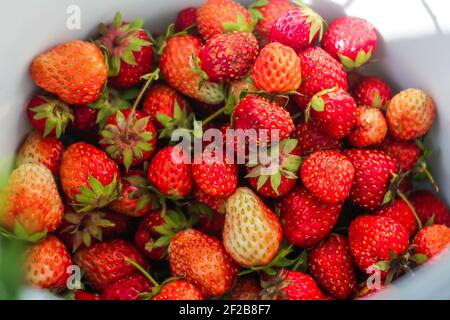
[153,280,204,300]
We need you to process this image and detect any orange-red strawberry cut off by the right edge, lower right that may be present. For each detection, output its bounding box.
[413,224,450,258]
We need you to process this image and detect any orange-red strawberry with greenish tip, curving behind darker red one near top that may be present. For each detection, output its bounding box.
[159,35,225,104]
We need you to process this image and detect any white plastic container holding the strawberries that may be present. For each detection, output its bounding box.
[0,0,450,299]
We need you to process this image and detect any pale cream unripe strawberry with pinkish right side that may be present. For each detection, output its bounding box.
[223,187,283,267]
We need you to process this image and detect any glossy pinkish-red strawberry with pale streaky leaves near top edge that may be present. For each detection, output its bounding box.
[270,5,324,51]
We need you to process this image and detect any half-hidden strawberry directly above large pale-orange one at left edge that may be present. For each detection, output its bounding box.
[16,131,65,175]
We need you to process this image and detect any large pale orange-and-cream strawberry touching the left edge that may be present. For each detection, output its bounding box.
[0,163,64,234]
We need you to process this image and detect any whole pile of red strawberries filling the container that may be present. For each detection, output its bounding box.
[0,0,450,300]
